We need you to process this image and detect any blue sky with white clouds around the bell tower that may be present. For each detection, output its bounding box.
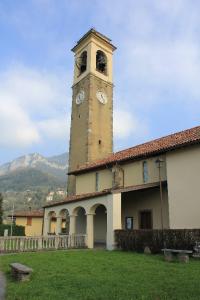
[0,0,200,165]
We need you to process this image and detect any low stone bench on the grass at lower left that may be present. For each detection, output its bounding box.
[10,263,33,281]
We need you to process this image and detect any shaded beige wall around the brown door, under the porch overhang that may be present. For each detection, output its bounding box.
[122,187,169,229]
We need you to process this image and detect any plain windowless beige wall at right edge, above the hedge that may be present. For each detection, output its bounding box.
[167,145,200,228]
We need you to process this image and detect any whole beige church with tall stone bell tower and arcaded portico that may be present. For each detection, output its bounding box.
[43,29,200,250]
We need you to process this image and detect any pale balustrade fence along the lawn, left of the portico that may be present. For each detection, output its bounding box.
[0,234,86,253]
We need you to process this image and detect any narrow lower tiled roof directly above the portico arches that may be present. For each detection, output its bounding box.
[43,189,111,208]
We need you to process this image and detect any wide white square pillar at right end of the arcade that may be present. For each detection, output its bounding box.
[106,193,122,250]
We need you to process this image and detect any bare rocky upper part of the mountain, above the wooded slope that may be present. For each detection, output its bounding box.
[0,153,68,191]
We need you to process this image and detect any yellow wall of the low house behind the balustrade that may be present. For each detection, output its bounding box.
[15,217,43,236]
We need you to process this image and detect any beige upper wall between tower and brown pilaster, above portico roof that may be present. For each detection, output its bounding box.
[76,170,112,194]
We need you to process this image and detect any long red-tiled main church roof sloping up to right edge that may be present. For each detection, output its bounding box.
[68,126,200,175]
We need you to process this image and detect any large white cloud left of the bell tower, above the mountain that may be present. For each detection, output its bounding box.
[0,65,69,148]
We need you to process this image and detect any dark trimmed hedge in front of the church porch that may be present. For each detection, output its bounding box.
[115,229,200,253]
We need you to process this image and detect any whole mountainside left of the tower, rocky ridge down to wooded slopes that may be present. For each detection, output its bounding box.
[0,153,68,216]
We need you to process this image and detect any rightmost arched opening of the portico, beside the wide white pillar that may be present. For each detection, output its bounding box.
[94,204,107,247]
